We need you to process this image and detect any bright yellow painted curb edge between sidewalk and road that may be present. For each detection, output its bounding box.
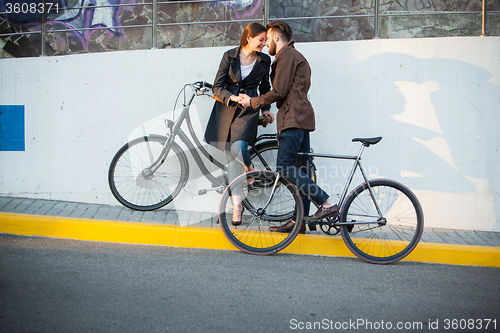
[0,213,500,267]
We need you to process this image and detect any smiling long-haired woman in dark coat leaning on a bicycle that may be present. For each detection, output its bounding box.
[205,22,272,225]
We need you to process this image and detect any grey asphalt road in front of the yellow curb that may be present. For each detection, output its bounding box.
[0,235,500,333]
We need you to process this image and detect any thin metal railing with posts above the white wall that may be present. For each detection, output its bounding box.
[0,0,500,56]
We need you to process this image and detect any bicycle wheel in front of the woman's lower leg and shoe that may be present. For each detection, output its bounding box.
[219,171,303,255]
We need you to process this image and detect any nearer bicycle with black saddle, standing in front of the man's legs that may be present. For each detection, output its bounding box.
[219,137,424,264]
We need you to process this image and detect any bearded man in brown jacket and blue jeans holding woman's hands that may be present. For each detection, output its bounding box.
[239,21,339,233]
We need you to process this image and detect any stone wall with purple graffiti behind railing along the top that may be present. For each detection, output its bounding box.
[0,0,500,58]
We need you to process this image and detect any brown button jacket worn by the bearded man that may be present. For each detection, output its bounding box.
[251,41,316,133]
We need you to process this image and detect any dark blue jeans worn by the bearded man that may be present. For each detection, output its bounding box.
[276,128,329,216]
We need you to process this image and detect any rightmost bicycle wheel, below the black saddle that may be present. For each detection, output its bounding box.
[340,179,424,264]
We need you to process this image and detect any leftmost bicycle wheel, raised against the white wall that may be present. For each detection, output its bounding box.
[108,135,189,211]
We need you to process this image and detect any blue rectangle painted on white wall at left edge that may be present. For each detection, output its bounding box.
[0,105,25,151]
